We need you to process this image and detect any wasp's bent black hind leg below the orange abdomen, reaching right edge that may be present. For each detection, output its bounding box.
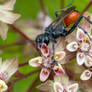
[64,16,92,36]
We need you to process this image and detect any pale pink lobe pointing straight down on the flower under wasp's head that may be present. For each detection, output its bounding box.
[40,68,51,82]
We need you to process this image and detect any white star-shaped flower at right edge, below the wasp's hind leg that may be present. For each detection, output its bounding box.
[66,28,92,67]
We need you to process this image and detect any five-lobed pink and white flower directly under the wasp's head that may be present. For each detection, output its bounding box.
[29,43,65,81]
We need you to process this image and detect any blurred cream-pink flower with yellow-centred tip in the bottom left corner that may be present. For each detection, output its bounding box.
[0,57,18,92]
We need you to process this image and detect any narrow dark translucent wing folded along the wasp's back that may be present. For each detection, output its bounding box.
[49,6,75,28]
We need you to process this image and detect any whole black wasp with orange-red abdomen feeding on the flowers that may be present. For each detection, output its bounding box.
[36,0,92,62]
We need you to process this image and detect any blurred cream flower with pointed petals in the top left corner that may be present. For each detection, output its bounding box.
[0,0,20,40]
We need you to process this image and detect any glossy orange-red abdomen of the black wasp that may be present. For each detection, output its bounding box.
[64,11,80,26]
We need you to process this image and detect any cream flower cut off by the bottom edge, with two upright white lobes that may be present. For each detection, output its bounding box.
[37,76,78,92]
